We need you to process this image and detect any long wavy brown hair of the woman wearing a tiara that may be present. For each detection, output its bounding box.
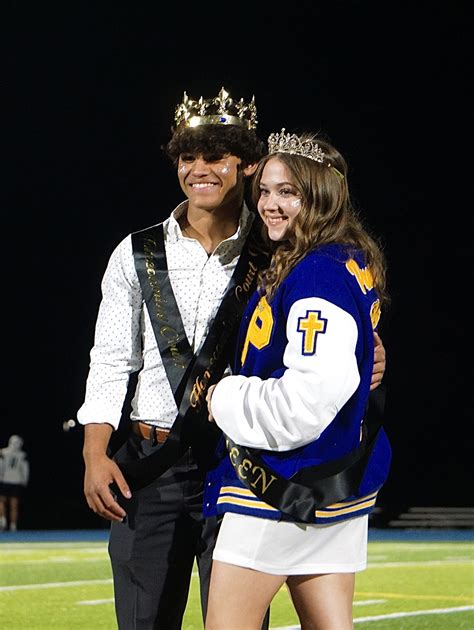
[252,134,389,303]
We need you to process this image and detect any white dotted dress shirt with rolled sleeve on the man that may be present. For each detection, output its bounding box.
[77,201,254,429]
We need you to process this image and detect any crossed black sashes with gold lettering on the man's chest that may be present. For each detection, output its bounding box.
[118,224,264,489]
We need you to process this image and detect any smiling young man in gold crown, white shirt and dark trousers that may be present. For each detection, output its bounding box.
[78,88,385,630]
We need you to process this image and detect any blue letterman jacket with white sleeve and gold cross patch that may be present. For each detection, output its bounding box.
[203,245,391,523]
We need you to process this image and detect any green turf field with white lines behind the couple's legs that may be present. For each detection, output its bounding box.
[0,538,474,630]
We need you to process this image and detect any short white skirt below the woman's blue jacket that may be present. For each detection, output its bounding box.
[212,512,369,575]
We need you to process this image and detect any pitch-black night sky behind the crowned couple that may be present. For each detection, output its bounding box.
[0,2,472,528]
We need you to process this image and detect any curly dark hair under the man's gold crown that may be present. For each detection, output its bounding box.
[164,125,267,166]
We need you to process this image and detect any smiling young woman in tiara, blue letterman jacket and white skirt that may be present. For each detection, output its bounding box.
[204,129,390,630]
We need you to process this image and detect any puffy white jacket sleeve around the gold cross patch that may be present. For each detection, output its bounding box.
[211,297,360,451]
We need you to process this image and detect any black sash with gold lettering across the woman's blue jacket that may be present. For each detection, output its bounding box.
[226,385,385,523]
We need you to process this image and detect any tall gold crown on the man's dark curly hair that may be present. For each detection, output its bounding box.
[174,87,257,129]
